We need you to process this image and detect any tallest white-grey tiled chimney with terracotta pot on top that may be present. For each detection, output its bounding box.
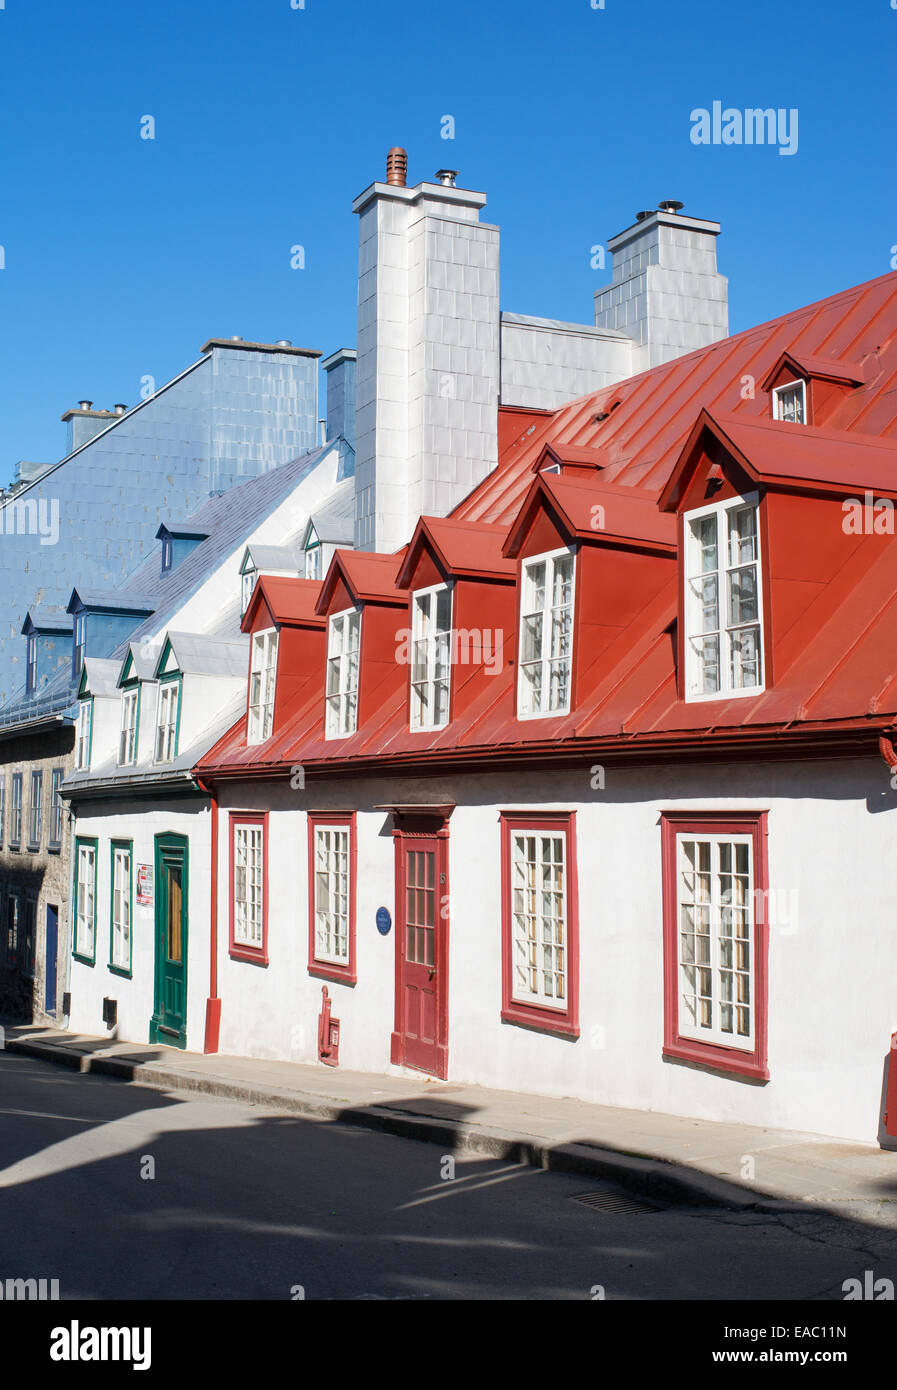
[353,150,499,550]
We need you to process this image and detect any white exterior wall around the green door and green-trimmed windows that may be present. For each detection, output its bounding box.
[68,796,211,1052]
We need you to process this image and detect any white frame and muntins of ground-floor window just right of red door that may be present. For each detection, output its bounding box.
[510,826,570,1013]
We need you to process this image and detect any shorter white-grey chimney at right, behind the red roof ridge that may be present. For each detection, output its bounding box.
[595,202,729,371]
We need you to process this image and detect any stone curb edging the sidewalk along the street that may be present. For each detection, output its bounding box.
[6,1038,778,1212]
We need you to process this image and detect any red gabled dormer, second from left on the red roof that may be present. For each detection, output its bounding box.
[317,550,407,738]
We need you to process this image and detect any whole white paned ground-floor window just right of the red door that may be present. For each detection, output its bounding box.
[510,830,567,1009]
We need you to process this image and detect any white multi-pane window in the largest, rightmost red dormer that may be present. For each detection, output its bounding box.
[686,496,763,699]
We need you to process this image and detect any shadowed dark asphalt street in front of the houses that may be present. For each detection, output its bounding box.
[0,1052,897,1301]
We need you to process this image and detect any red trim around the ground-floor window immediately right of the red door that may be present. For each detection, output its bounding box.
[501,810,580,1038]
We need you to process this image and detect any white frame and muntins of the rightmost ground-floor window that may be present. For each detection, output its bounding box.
[676,830,759,1052]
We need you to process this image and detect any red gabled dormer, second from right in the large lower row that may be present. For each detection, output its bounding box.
[503,473,676,719]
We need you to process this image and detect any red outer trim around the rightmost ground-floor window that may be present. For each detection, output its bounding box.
[661,810,769,1081]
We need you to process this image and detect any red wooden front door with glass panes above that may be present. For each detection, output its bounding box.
[392,831,448,1077]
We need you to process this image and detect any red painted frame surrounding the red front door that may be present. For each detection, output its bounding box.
[389,812,452,1081]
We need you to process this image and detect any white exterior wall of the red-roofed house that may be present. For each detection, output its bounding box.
[218,759,897,1140]
